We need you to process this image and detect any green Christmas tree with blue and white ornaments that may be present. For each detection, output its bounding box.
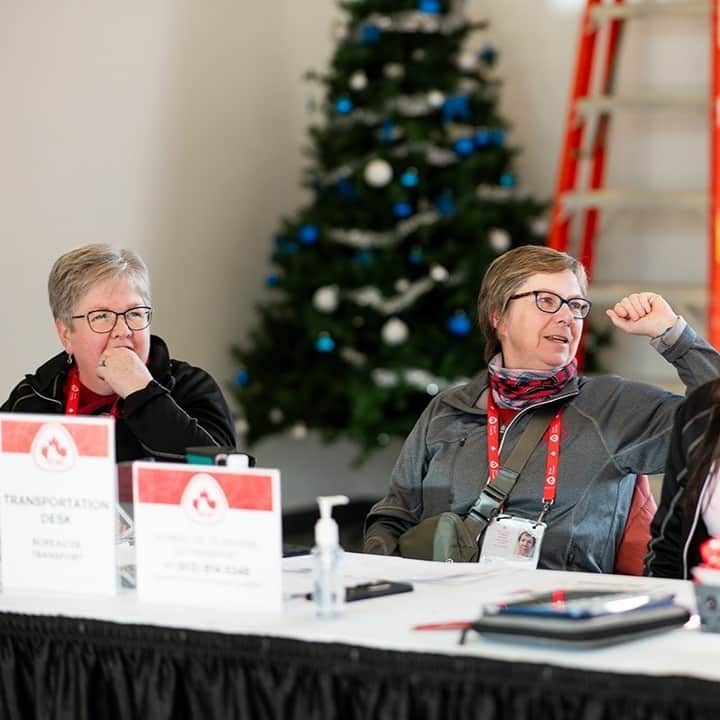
[233,0,544,454]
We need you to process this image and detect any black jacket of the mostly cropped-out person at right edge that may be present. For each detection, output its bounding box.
[645,381,717,579]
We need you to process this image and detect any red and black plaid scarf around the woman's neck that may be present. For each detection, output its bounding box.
[488,353,577,410]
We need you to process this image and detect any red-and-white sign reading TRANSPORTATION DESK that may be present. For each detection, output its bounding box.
[0,413,117,595]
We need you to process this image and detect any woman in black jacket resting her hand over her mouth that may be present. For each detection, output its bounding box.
[0,244,235,462]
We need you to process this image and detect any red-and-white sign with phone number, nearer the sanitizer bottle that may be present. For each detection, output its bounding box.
[133,462,282,612]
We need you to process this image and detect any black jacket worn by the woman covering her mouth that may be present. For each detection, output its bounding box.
[0,335,235,462]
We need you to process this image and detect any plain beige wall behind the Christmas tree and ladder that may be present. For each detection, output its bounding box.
[0,0,707,506]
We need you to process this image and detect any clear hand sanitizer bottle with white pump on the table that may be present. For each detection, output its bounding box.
[312,495,349,618]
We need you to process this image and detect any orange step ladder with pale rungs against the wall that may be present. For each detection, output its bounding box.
[547,0,720,348]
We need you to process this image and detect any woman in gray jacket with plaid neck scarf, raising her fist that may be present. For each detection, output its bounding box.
[365,246,720,574]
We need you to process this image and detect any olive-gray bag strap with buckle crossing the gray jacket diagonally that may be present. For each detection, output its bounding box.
[465,403,558,539]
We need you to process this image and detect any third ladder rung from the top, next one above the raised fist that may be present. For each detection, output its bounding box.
[562,188,708,211]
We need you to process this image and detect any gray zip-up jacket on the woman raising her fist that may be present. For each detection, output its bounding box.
[365,319,720,572]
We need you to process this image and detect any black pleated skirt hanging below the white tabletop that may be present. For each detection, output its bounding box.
[0,614,720,720]
